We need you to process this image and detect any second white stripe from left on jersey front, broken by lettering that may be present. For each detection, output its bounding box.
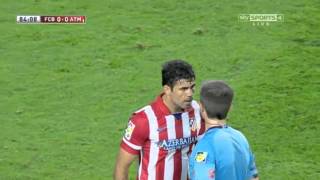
[164,115,176,179]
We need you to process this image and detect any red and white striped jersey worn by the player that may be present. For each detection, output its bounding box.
[121,95,205,180]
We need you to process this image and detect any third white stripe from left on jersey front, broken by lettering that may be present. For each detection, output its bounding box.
[181,112,191,180]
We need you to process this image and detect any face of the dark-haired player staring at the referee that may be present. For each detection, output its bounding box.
[170,79,195,110]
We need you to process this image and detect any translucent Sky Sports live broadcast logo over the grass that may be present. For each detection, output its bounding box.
[238,14,284,26]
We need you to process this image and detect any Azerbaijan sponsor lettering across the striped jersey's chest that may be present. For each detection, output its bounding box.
[157,137,197,150]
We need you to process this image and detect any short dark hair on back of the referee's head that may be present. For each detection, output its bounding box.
[200,80,233,120]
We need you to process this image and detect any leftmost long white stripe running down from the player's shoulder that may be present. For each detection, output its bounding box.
[144,106,159,180]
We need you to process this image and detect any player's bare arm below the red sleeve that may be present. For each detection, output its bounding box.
[113,148,137,180]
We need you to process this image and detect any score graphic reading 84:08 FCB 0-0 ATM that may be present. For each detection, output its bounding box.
[17,15,87,24]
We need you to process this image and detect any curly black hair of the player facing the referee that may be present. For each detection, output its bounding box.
[161,60,196,88]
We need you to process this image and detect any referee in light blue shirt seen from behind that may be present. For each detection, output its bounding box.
[189,81,259,180]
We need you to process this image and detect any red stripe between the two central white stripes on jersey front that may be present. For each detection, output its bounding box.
[173,119,183,179]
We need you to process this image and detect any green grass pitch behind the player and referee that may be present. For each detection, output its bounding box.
[0,0,320,180]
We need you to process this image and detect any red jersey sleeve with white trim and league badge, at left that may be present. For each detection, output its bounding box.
[120,112,149,154]
